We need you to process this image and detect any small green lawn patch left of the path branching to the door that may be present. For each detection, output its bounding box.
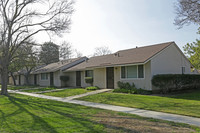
[43,88,91,97]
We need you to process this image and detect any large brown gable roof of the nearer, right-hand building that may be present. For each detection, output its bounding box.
[67,42,175,71]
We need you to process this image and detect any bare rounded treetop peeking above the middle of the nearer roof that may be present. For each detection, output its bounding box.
[93,46,112,56]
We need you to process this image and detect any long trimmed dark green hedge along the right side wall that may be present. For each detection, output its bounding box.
[152,74,200,93]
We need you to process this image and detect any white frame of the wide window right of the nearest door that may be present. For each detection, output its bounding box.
[120,64,145,80]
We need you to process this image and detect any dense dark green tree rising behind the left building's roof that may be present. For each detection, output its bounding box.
[39,42,59,65]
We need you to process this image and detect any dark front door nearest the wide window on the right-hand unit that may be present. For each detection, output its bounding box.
[106,67,114,89]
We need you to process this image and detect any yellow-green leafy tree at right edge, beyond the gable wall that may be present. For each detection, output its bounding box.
[183,40,200,69]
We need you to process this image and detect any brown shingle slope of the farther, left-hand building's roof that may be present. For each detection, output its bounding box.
[32,57,85,74]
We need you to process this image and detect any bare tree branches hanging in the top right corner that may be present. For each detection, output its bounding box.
[174,0,200,31]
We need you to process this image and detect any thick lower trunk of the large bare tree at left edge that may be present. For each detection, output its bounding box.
[1,67,8,96]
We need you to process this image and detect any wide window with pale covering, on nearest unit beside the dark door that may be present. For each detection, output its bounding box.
[121,65,144,78]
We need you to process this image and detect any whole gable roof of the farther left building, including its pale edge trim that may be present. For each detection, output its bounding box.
[31,57,86,74]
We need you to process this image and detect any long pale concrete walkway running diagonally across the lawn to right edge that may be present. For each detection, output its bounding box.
[9,90,200,126]
